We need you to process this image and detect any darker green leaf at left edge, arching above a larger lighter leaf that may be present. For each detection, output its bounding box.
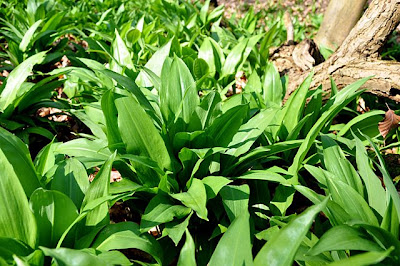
[0,127,40,197]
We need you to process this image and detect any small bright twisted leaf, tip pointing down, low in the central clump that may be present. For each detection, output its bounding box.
[171,178,208,221]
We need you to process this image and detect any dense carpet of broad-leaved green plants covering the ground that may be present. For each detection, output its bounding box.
[0,0,400,265]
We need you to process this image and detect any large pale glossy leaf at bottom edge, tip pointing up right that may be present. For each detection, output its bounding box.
[254,198,328,266]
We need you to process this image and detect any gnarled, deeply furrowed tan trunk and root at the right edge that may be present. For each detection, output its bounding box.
[286,0,400,102]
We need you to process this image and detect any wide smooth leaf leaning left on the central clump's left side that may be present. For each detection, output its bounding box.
[115,90,171,171]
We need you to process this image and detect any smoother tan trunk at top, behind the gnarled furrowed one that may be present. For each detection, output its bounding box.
[314,0,367,51]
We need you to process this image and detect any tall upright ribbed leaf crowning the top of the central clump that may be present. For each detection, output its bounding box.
[160,57,200,124]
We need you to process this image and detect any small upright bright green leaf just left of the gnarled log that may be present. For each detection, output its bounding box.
[262,63,282,105]
